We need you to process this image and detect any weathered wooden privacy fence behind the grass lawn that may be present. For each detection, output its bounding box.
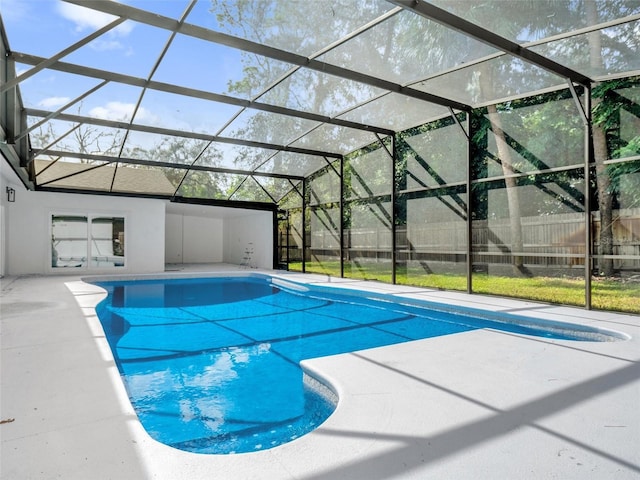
[288,208,640,270]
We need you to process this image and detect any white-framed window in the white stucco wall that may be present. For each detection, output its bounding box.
[51,215,125,269]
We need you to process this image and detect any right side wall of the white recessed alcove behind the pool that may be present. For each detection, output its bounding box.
[224,211,274,268]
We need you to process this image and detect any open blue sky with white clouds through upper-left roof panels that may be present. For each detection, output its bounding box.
[1,0,242,133]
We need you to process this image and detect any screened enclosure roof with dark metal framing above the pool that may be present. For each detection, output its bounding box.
[0,0,640,203]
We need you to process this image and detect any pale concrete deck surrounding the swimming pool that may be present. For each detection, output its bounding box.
[0,265,640,480]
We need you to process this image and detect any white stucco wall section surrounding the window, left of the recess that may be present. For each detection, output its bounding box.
[3,189,165,275]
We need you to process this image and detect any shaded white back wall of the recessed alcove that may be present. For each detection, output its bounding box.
[165,213,224,263]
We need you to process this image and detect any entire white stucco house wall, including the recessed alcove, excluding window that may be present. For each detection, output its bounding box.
[0,161,274,275]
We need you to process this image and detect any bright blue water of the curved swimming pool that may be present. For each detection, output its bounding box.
[96,275,614,454]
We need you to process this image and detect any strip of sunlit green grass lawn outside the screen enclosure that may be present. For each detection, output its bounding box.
[289,262,640,313]
